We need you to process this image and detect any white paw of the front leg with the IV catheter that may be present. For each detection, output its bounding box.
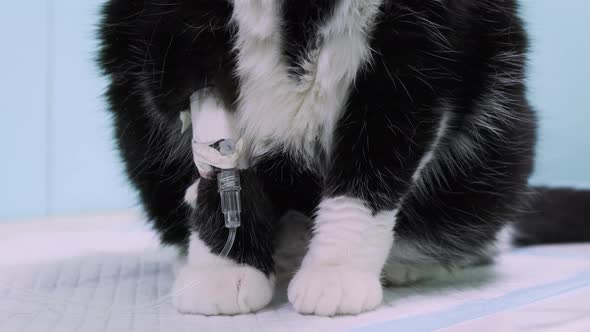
[172,265,274,315]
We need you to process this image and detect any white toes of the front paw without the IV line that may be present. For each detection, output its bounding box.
[289,266,383,316]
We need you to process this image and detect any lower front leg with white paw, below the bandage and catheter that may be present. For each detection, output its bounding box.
[173,171,277,315]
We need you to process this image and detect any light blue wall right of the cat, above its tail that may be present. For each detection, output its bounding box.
[521,0,590,187]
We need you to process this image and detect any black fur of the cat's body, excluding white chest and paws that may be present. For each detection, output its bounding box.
[100,0,588,280]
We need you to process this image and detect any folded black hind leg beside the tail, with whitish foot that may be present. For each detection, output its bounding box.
[384,116,532,285]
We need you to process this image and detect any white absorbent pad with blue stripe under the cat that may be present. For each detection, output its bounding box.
[0,216,590,332]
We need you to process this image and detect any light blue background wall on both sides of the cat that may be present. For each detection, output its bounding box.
[0,0,590,220]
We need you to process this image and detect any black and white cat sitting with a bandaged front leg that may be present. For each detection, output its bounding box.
[100,0,590,315]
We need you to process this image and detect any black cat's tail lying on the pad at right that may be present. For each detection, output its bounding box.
[513,187,590,246]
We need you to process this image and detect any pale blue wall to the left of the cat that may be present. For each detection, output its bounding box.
[0,0,135,220]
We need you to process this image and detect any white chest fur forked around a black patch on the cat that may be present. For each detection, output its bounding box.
[233,0,383,165]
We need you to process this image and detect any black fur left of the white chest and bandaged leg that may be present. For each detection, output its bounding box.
[100,0,233,244]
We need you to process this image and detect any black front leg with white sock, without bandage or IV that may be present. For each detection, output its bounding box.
[288,91,440,316]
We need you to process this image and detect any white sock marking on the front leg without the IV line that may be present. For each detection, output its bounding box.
[289,197,397,316]
